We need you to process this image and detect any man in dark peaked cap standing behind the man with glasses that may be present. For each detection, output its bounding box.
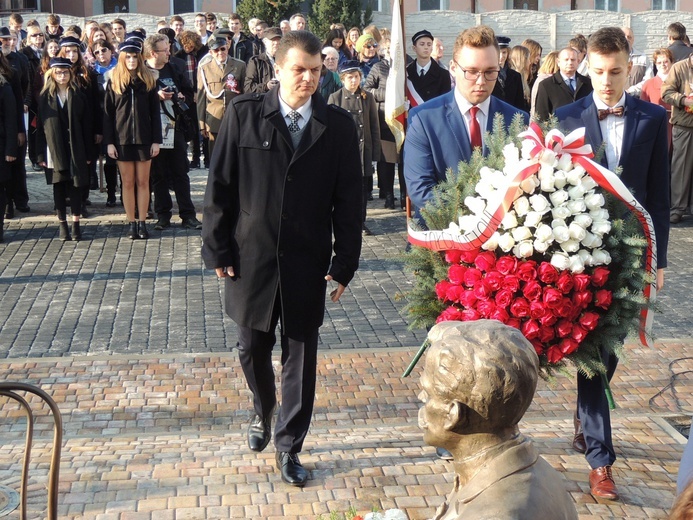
[407,29,452,104]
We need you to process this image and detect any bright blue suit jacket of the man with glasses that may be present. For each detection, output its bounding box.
[404,92,529,214]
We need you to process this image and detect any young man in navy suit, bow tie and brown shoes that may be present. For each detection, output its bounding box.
[556,27,669,500]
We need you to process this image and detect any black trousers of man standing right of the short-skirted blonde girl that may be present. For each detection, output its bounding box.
[150,132,195,219]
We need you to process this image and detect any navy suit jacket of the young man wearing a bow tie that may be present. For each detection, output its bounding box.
[556,95,669,268]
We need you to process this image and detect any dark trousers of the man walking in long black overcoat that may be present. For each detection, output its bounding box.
[238,297,318,453]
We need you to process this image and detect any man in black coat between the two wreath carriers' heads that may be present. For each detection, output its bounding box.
[535,47,592,121]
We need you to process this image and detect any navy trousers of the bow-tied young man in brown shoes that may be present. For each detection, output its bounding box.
[577,352,618,469]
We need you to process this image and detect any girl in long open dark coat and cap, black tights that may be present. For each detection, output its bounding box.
[36,57,94,241]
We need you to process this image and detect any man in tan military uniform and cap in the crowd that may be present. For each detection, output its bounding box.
[197,33,246,157]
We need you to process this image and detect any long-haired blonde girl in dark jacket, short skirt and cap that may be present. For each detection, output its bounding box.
[103,40,162,240]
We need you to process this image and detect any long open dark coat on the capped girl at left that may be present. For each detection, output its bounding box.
[36,89,96,186]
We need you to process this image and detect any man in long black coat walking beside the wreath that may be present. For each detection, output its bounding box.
[202,31,361,486]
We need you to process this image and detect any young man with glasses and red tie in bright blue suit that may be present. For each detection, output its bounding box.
[404,25,529,219]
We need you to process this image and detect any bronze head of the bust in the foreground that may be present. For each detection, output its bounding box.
[419,320,539,453]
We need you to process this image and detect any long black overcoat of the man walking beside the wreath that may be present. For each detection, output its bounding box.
[202,87,361,335]
